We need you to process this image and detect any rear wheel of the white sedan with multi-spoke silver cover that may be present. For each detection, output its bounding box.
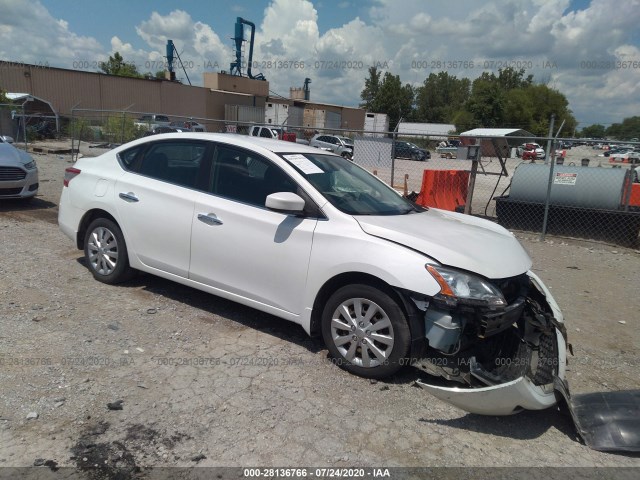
[84,218,134,284]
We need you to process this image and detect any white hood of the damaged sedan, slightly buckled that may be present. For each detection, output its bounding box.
[354,208,531,279]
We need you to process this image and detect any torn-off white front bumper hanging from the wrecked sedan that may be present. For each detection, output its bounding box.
[416,272,567,415]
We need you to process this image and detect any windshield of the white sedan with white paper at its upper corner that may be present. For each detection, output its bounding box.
[282,153,424,215]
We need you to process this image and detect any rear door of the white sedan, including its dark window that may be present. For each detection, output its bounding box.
[116,140,213,278]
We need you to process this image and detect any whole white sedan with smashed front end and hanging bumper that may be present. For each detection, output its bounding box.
[59,132,566,415]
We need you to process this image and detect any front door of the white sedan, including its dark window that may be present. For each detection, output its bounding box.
[189,145,318,315]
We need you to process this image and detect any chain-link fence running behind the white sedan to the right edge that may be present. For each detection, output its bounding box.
[68,109,640,247]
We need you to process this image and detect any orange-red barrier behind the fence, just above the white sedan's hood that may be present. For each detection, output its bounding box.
[416,170,469,212]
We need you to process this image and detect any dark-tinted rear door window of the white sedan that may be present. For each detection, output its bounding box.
[137,141,208,190]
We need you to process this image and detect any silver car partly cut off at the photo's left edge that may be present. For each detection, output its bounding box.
[0,136,38,199]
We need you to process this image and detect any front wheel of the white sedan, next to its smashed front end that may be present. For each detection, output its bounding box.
[322,285,411,378]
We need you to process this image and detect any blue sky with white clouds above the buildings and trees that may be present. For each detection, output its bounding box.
[0,0,640,126]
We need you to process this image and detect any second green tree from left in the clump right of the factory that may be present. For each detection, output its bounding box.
[416,72,471,123]
